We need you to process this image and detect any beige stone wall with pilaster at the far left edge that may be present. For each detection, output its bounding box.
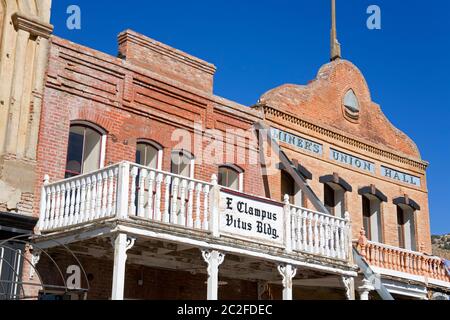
[0,0,53,215]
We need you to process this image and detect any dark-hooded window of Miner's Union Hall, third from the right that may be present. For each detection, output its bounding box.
[319,173,352,218]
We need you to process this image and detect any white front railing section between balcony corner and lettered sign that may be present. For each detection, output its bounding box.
[128,164,213,230]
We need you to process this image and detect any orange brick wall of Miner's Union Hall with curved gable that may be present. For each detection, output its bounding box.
[260,60,431,253]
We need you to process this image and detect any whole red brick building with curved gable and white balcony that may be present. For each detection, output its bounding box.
[0,0,450,299]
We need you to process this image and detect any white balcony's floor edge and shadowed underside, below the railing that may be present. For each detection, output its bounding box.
[34,217,357,280]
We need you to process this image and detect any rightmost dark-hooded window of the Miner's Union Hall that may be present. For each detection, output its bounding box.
[394,197,420,251]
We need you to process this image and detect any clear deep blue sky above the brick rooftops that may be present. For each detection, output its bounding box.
[52,0,450,233]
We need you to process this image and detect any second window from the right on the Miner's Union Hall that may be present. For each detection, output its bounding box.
[358,185,387,242]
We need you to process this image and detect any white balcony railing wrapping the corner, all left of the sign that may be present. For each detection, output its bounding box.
[39,162,213,232]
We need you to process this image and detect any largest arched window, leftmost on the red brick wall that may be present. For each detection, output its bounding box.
[65,122,106,178]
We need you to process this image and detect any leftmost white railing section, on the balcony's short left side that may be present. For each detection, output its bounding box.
[39,165,119,231]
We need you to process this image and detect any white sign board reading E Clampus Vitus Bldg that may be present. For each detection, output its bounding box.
[220,189,284,246]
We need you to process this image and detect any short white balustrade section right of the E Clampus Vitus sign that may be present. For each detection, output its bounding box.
[291,205,351,260]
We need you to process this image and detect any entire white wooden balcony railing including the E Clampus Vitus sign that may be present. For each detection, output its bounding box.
[39,162,351,262]
